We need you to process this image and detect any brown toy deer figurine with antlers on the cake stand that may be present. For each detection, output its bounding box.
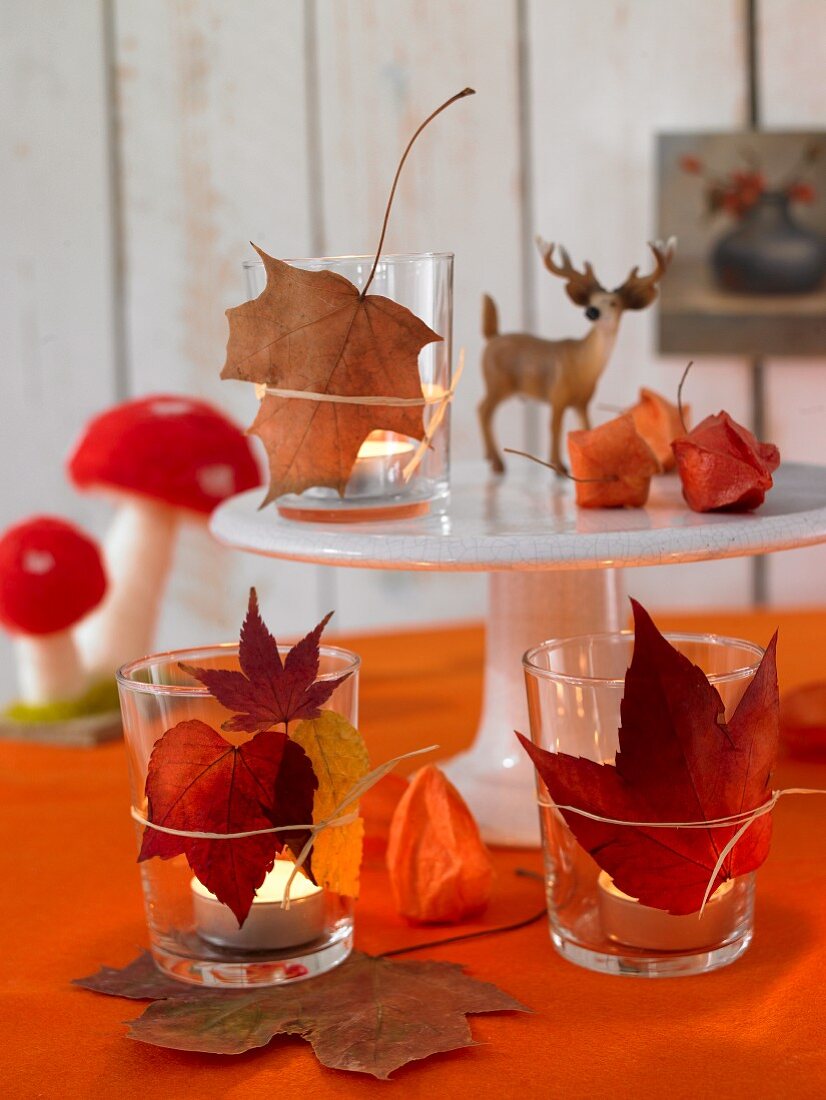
[478,238,676,473]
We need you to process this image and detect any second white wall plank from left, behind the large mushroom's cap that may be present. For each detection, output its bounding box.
[115,0,320,646]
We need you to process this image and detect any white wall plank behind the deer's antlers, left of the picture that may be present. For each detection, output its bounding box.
[529,0,751,607]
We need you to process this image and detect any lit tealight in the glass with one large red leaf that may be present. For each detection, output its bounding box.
[597,871,737,952]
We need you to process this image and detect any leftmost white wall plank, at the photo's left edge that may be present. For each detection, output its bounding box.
[0,0,118,700]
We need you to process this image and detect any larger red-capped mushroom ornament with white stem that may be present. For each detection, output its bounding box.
[68,394,261,673]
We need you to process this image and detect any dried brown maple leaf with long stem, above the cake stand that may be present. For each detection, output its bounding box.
[221,88,473,506]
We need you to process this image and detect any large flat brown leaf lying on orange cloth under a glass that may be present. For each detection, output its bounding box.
[77,952,528,1079]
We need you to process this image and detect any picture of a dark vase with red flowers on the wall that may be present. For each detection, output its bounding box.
[657,131,826,358]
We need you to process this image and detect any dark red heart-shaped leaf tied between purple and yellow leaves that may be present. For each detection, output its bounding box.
[137,719,318,926]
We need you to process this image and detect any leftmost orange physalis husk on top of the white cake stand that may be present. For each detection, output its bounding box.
[568,413,660,508]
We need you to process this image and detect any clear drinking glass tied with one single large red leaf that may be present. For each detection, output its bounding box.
[522,631,763,978]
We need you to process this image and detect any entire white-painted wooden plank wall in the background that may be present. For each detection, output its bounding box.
[0,0,826,697]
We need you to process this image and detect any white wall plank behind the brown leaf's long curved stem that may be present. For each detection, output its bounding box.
[318,0,522,626]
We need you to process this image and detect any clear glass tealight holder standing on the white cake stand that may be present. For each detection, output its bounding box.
[244,252,453,523]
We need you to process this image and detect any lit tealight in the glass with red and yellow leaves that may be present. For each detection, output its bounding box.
[190,859,324,952]
